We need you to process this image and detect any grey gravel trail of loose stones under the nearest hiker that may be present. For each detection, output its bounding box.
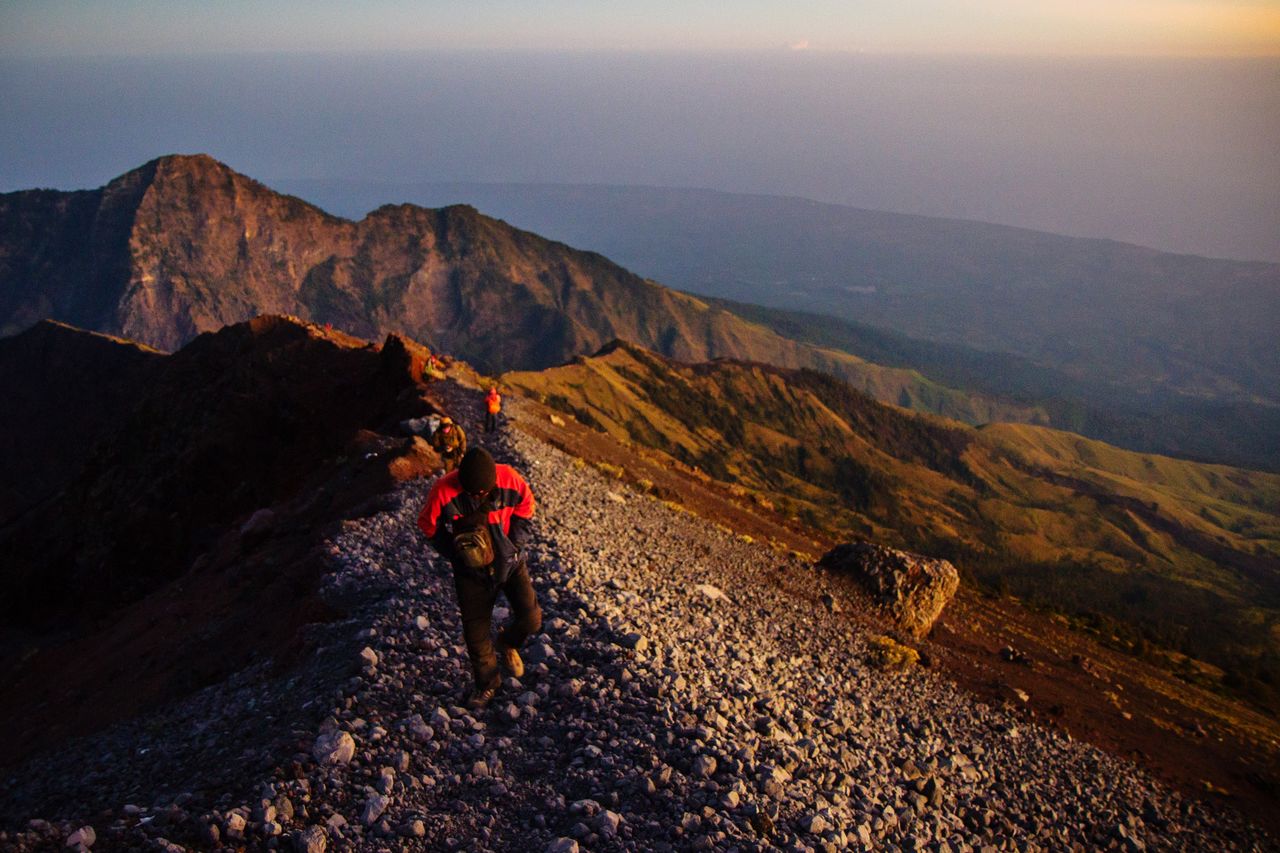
[0,388,1274,852]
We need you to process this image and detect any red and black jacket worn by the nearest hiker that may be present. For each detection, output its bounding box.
[417,465,534,565]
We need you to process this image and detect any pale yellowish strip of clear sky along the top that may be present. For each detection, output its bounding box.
[0,0,1280,56]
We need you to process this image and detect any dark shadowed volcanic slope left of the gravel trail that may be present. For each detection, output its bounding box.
[0,312,438,766]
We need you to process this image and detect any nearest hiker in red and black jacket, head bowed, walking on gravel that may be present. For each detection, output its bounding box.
[417,447,543,710]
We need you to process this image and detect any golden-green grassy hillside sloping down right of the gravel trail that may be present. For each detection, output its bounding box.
[506,345,1280,711]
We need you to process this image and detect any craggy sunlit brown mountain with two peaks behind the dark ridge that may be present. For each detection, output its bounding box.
[0,156,1043,423]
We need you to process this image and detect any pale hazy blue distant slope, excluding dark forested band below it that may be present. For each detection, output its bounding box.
[283,181,1280,403]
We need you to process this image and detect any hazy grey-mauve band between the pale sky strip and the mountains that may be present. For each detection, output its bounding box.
[0,51,1280,261]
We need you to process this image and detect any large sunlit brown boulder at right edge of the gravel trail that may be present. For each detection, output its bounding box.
[818,542,960,639]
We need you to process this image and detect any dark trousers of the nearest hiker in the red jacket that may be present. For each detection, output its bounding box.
[453,564,543,688]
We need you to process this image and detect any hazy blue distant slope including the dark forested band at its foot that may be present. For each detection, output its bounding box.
[284,181,1280,471]
